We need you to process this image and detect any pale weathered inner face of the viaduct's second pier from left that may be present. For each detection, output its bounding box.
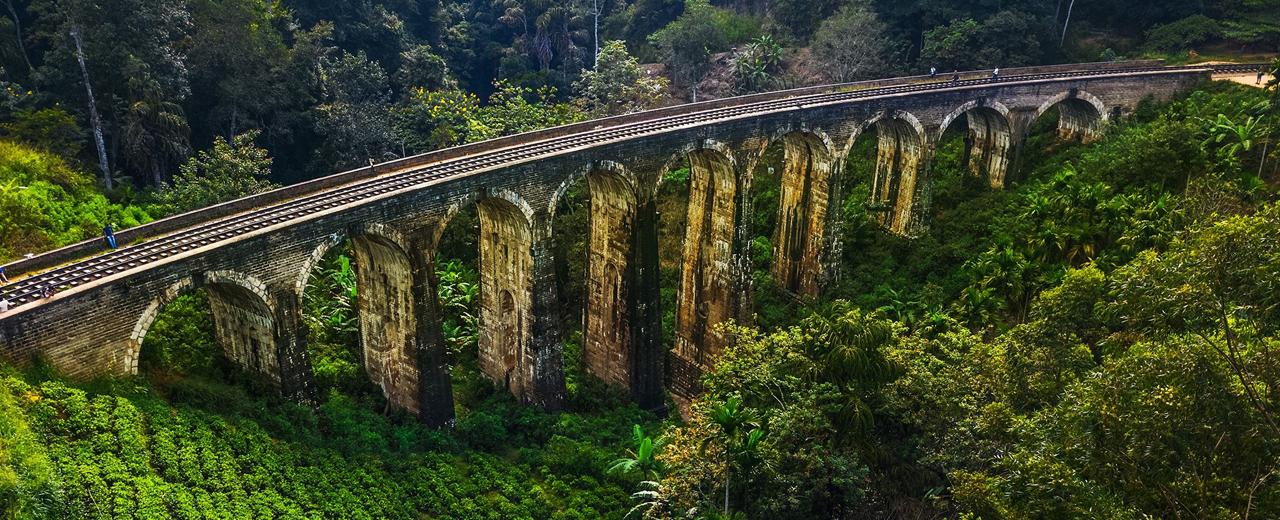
[352,234,419,414]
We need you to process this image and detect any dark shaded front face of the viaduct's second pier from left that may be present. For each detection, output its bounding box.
[408,233,453,428]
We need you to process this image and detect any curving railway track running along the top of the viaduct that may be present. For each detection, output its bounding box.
[3,65,1261,307]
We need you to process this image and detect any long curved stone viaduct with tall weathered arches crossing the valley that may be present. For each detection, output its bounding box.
[0,64,1211,424]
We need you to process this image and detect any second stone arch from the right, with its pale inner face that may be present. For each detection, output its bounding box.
[934,100,1014,188]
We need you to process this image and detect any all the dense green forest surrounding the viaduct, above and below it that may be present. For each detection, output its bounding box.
[0,0,1280,520]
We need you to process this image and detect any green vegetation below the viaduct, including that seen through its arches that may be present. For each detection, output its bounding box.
[0,77,1280,519]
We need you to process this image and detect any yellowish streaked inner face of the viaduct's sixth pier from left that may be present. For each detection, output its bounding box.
[772,132,832,297]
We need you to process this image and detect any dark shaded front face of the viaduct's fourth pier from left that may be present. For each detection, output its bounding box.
[627,200,667,415]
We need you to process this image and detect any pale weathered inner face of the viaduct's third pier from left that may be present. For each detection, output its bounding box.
[476,197,536,401]
